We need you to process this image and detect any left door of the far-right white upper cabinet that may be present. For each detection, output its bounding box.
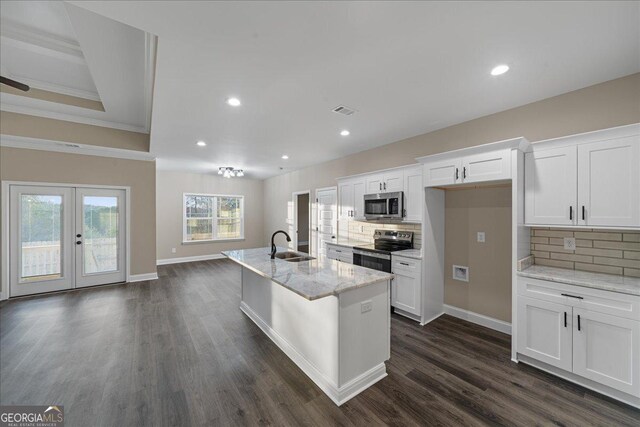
[524,147,578,225]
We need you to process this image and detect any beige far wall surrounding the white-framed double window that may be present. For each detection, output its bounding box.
[156,171,266,260]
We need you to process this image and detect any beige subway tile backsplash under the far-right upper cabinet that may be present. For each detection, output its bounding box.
[531,227,640,277]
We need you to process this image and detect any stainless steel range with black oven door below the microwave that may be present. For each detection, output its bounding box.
[353,230,413,273]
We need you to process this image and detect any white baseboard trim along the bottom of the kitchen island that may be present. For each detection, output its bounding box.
[240,301,387,406]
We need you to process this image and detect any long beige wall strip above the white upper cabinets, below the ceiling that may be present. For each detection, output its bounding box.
[263,73,640,318]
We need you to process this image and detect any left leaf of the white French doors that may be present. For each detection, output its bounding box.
[9,185,74,297]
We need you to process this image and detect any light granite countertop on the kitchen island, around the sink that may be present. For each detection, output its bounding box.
[222,248,394,300]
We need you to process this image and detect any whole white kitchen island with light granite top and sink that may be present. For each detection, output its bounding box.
[223,248,393,405]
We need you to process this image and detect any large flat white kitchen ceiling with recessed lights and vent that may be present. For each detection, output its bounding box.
[42,1,640,178]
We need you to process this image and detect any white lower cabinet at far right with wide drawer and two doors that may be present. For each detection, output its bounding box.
[516,277,640,398]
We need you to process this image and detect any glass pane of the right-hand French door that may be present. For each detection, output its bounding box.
[82,196,119,274]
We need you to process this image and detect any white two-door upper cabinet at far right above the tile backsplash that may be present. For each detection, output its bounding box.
[525,125,640,227]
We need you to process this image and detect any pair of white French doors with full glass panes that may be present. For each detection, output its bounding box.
[9,185,126,297]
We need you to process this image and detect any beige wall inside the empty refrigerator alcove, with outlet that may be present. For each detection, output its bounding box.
[444,185,511,322]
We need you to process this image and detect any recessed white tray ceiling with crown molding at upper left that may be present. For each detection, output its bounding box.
[0,1,155,132]
